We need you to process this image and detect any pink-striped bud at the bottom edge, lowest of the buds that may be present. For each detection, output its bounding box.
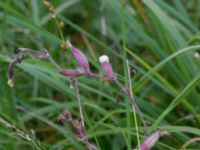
[140,131,169,150]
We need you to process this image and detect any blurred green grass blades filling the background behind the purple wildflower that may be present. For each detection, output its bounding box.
[0,0,200,150]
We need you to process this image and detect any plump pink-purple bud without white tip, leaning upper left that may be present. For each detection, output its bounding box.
[72,47,90,73]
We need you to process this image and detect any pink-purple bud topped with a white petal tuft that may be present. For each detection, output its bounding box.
[99,55,116,80]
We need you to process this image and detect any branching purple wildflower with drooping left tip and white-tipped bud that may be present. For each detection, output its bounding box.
[7,41,148,149]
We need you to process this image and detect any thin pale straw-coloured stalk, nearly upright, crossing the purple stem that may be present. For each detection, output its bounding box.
[127,60,141,150]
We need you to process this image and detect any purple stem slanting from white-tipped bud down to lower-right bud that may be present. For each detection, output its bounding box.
[113,80,148,134]
